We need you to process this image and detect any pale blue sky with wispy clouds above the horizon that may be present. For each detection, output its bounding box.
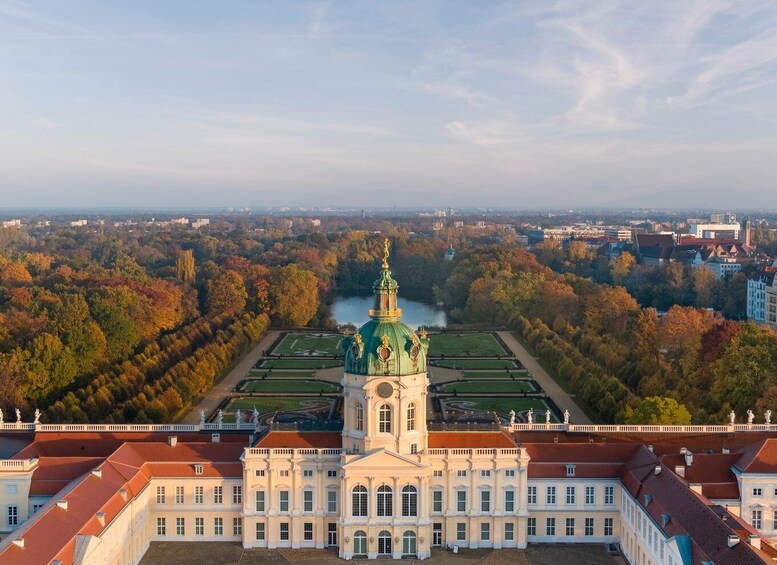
[0,0,777,209]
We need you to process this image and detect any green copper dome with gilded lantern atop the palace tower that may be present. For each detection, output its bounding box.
[343,240,429,377]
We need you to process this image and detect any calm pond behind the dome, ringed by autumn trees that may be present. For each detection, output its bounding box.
[332,291,447,329]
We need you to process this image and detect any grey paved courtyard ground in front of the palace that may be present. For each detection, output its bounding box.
[140,542,626,565]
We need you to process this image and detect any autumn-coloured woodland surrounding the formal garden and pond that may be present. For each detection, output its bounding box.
[0,222,777,423]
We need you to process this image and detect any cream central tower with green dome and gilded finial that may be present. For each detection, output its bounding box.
[342,239,429,454]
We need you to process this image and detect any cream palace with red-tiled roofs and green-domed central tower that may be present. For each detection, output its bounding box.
[0,249,777,565]
